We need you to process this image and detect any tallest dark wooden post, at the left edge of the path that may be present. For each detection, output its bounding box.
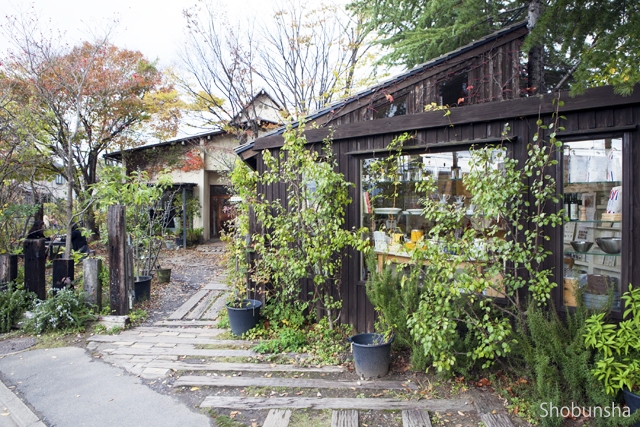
[107,205,131,316]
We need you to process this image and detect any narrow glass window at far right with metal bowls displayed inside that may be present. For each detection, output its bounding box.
[563,139,624,311]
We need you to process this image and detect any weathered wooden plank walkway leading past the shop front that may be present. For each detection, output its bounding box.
[89,270,513,427]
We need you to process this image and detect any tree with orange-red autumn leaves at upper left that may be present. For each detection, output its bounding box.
[0,16,180,247]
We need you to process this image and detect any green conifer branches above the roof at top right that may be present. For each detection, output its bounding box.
[350,0,640,94]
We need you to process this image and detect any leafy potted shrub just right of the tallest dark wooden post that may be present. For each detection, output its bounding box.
[94,167,177,301]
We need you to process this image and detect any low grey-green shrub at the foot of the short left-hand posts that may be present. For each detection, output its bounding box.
[27,289,94,334]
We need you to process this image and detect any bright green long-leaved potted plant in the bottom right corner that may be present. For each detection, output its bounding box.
[585,284,640,427]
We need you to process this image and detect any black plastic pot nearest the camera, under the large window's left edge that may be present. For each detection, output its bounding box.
[349,334,394,378]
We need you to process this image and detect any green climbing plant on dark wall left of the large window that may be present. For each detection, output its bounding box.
[252,124,368,329]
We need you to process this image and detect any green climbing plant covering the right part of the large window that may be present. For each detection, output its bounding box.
[408,101,564,371]
